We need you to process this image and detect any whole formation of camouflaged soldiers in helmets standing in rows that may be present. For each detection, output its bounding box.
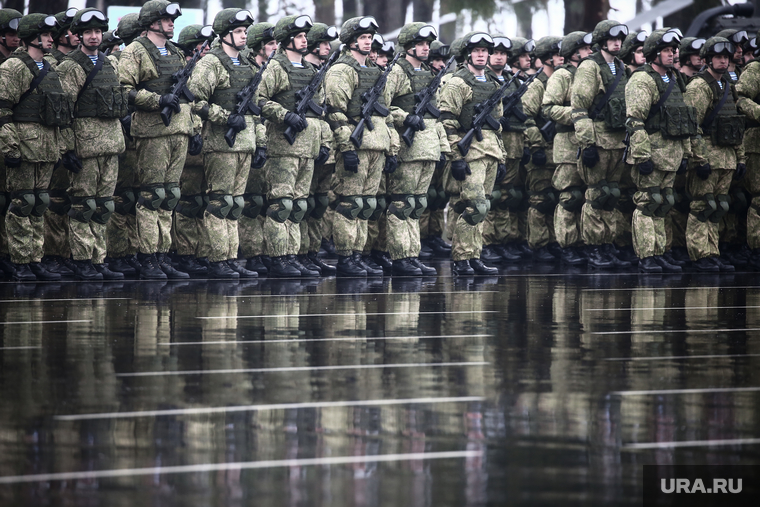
[0,0,760,282]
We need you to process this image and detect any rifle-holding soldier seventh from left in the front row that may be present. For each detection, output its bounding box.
[384,23,451,276]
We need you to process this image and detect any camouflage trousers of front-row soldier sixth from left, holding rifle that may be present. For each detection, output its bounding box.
[333,150,385,256]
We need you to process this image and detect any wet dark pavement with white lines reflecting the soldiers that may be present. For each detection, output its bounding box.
[0,263,760,507]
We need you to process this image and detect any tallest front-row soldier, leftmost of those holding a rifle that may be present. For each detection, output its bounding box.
[119,0,197,280]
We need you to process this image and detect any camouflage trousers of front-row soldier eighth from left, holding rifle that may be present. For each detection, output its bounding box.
[451,157,499,261]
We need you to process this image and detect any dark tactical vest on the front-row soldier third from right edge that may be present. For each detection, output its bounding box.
[634,64,697,139]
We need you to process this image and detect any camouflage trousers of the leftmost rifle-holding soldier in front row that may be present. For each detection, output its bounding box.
[135,134,189,254]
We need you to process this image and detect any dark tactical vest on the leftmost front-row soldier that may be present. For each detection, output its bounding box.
[8,52,73,127]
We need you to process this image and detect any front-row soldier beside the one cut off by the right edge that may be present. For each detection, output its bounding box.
[684,37,747,272]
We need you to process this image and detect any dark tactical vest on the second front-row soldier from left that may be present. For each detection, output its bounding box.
[69,49,129,118]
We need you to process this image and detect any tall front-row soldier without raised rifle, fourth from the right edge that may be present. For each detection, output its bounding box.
[570,20,631,268]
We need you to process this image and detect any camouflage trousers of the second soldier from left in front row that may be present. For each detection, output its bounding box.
[67,155,119,264]
